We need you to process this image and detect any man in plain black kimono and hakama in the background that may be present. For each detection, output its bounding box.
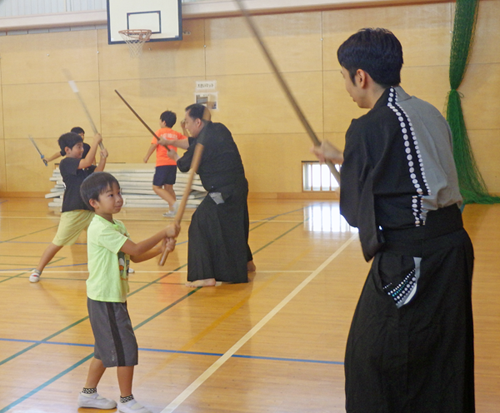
[167,104,255,287]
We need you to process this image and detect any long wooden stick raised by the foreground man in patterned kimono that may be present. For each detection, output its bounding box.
[235,0,340,183]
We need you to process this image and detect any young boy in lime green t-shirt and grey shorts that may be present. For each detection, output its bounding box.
[78,172,180,413]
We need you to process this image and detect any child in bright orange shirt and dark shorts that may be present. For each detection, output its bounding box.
[144,110,187,217]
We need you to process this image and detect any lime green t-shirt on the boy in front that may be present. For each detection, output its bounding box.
[87,215,130,303]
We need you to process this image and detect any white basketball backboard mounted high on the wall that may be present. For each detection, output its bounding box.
[107,0,182,44]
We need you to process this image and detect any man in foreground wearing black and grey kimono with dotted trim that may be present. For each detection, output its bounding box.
[314,29,475,413]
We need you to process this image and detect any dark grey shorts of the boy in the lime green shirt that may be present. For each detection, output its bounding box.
[87,298,139,367]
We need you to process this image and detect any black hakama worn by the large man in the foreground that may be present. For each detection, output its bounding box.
[345,207,475,413]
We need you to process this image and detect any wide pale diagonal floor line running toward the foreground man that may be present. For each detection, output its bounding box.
[161,234,358,413]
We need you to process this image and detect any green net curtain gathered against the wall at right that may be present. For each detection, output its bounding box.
[446,0,500,204]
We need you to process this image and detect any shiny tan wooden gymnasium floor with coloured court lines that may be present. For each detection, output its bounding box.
[0,199,500,413]
